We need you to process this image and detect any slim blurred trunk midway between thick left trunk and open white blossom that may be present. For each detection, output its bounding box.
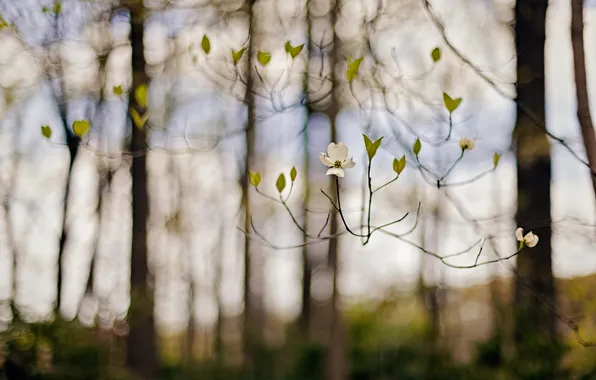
[241,0,259,373]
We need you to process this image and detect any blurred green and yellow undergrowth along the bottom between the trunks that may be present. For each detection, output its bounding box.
[0,276,596,380]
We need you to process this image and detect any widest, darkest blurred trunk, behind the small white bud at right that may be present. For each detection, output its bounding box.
[514,0,559,379]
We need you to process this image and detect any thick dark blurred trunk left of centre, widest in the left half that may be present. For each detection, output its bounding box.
[127,1,158,379]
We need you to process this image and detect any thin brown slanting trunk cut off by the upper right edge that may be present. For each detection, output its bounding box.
[571,0,596,197]
